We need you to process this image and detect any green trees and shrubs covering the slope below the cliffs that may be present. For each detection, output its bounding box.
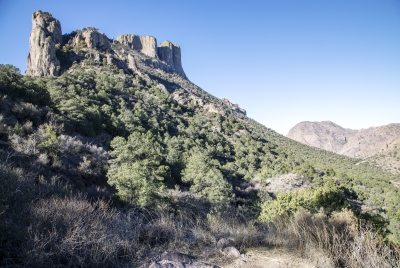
[0,35,400,266]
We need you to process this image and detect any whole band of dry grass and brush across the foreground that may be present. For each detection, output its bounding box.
[0,158,400,267]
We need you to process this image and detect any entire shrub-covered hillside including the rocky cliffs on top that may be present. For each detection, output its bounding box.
[0,11,400,267]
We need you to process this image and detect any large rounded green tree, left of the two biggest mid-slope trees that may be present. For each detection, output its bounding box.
[107,132,170,207]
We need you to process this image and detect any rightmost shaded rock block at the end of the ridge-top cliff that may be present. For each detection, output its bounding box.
[157,41,186,78]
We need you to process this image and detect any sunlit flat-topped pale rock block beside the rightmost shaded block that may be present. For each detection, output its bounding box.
[117,34,158,59]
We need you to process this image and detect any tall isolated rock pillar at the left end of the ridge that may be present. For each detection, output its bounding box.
[26,10,62,76]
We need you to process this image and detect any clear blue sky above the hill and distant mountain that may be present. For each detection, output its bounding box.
[0,0,400,135]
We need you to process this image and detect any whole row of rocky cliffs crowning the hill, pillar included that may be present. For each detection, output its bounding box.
[26,11,187,79]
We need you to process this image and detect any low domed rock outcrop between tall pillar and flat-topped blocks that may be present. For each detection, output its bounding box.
[68,28,111,49]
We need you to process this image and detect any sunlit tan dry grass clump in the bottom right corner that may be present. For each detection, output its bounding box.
[268,209,400,267]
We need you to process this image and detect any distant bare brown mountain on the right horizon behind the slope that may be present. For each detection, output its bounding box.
[287,121,400,158]
